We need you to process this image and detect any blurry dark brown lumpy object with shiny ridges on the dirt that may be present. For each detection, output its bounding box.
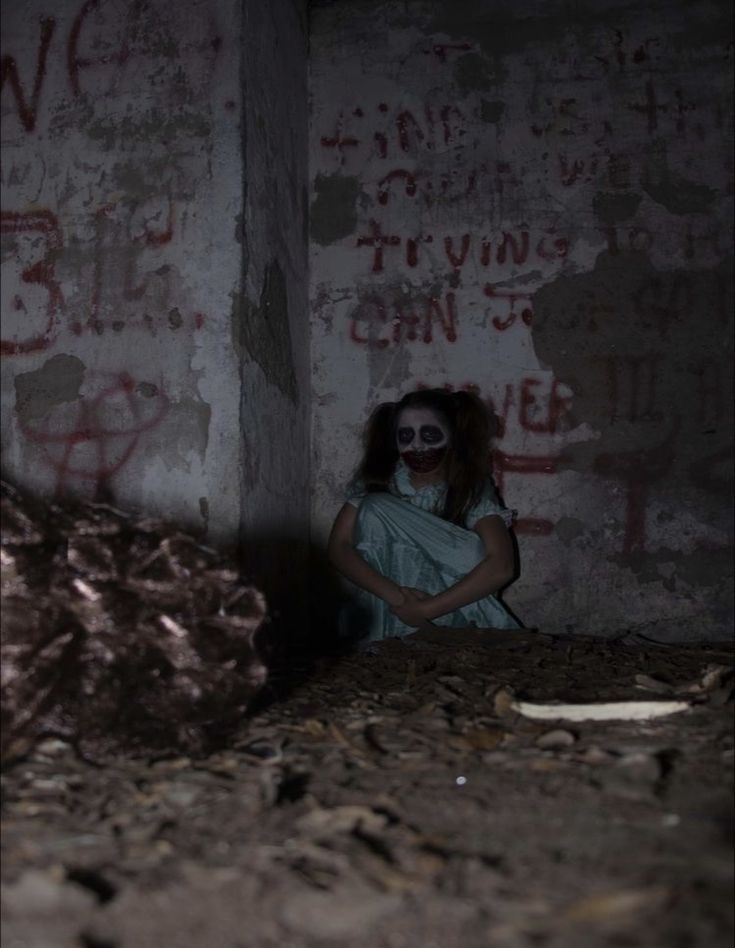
[1,483,266,763]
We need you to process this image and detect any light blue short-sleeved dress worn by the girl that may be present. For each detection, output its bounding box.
[340,461,520,642]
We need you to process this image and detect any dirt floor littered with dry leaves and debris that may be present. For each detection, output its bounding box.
[2,631,733,948]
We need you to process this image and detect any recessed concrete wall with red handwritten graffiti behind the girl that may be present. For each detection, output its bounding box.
[310,0,733,638]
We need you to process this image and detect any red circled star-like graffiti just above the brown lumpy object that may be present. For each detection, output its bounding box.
[20,372,169,496]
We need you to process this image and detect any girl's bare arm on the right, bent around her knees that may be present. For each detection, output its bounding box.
[393,515,514,625]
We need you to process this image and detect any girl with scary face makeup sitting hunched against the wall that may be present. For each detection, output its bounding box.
[328,389,519,641]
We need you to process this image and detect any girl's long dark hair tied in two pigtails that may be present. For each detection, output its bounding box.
[355,388,491,526]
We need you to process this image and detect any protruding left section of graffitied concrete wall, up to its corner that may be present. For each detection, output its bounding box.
[2,0,309,600]
